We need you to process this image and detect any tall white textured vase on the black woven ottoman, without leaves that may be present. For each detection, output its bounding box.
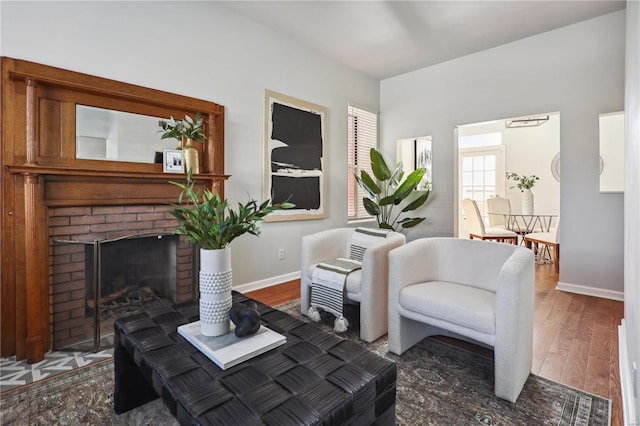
[200,248,233,336]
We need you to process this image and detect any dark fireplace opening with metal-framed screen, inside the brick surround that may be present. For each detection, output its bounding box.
[52,234,179,352]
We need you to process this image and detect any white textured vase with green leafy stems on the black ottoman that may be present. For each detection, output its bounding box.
[170,172,294,336]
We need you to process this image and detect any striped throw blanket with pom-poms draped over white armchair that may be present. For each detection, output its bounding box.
[307,228,389,333]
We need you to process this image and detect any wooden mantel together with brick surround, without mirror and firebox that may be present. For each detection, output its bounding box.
[0,57,229,363]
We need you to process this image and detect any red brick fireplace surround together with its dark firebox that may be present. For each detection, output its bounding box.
[48,205,197,351]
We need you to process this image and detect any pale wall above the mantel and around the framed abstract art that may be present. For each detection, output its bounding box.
[0,1,379,286]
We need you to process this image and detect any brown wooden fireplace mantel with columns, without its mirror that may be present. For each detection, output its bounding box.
[0,57,228,363]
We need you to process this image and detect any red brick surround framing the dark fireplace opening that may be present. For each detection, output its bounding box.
[49,205,196,348]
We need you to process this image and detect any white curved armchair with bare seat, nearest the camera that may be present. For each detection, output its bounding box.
[388,238,535,402]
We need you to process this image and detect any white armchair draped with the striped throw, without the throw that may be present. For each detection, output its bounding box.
[300,228,406,342]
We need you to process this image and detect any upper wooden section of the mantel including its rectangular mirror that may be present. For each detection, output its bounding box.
[3,58,224,176]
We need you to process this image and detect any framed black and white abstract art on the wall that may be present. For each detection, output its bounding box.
[264,90,327,221]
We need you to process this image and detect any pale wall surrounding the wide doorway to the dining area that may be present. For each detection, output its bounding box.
[380,11,625,297]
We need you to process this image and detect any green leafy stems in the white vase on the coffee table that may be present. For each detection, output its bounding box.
[169,173,295,250]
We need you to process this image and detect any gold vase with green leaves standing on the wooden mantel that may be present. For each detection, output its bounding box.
[159,112,204,174]
